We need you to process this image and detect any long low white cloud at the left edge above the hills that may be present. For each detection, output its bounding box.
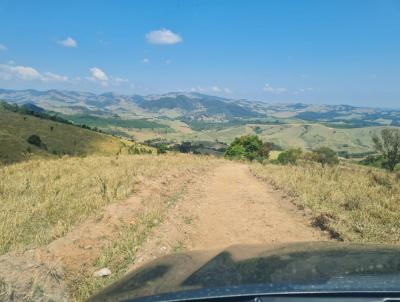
[0,62,68,82]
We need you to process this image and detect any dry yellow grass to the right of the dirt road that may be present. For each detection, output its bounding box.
[252,164,400,243]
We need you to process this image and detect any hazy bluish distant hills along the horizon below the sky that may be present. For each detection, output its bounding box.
[0,89,400,126]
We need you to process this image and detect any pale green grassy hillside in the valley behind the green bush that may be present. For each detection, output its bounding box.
[134,122,384,153]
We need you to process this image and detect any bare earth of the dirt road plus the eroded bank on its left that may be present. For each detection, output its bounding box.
[0,162,327,301]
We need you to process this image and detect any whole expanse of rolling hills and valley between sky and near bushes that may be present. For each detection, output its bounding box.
[0,89,400,155]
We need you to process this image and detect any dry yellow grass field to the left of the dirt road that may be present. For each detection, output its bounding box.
[0,154,216,254]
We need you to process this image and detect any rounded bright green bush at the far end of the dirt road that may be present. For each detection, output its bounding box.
[225,135,273,161]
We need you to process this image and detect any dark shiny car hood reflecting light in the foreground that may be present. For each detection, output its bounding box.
[90,242,400,301]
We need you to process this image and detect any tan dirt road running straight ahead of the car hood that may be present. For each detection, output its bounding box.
[133,162,327,268]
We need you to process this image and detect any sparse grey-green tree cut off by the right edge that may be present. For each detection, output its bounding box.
[372,128,400,171]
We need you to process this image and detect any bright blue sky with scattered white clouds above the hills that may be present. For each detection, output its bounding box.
[0,0,400,108]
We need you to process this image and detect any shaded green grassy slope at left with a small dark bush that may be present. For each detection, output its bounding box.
[0,109,152,163]
